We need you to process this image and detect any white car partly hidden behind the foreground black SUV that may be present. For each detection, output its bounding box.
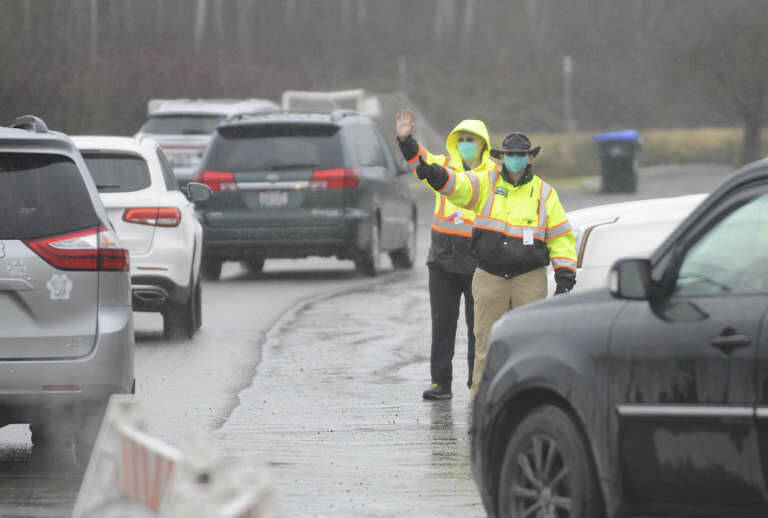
[548,194,707,296]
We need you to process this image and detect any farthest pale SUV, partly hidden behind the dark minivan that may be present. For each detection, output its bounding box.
[136,99,280,184]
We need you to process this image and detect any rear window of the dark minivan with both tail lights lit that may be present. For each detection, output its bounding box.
[205,124,344,172]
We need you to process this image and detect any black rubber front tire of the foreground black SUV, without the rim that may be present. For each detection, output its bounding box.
[497,405,605,518]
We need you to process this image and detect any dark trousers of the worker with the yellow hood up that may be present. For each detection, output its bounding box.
[429,266,475,388]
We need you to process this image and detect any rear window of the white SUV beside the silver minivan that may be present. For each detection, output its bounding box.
[83,153,151,196]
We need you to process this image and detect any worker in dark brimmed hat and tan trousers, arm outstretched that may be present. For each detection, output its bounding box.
[416,133,576,398]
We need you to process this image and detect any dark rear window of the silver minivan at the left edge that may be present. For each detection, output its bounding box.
[0,153,100,239]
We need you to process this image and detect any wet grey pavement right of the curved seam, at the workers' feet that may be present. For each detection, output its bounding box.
[217,272,484,516]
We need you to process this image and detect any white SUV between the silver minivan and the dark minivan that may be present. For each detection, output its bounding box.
[72,136,211,338]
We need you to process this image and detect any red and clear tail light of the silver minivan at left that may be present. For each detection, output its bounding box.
[25,225,130,272]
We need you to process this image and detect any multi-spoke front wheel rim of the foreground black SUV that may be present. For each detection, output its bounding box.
[509,434,572,518]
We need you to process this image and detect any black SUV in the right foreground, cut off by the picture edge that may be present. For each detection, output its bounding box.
[472,160,768,517]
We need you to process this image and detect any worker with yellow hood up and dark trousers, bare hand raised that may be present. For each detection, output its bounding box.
[396,110,496,400]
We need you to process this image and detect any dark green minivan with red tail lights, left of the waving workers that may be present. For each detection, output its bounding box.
[198,110,416,279]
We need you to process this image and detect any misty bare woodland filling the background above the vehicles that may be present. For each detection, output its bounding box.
[0,0,768,165]
